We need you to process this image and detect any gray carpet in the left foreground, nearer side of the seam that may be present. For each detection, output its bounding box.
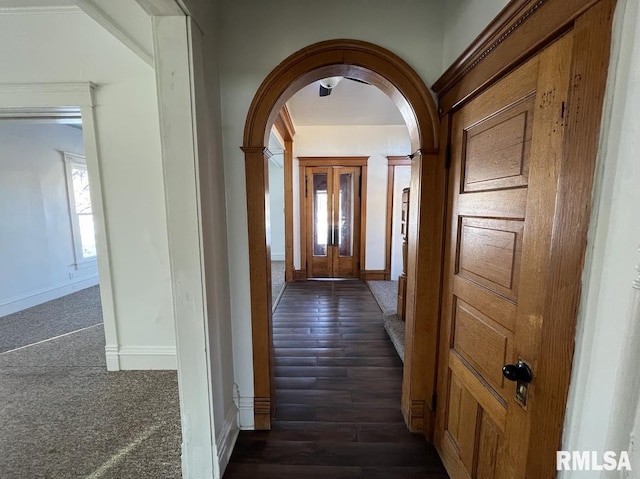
[0,288,181,479]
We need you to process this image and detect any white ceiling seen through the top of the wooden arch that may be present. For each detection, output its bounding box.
[287,78,405,126]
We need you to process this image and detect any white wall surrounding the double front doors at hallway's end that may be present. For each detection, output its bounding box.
[293,125,411,270]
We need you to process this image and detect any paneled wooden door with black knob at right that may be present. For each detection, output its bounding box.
[435,33,575,479]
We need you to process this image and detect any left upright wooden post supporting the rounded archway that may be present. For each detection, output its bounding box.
[242,147,275,429]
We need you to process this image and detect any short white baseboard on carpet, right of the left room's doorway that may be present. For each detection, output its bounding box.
[111,346,178,371]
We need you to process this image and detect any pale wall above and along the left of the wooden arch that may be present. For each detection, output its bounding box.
[220,0,444,427]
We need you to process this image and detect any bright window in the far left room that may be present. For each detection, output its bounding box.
[64,152,96,267]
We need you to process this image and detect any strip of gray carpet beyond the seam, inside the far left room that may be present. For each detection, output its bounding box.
[0,286,102,353]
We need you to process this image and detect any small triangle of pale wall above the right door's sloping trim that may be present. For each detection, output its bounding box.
[442,0,509,71]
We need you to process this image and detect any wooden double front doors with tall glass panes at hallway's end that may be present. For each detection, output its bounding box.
[305,166,360,278]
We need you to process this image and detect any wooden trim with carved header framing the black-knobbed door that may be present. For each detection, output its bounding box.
[434,0,616,478]
